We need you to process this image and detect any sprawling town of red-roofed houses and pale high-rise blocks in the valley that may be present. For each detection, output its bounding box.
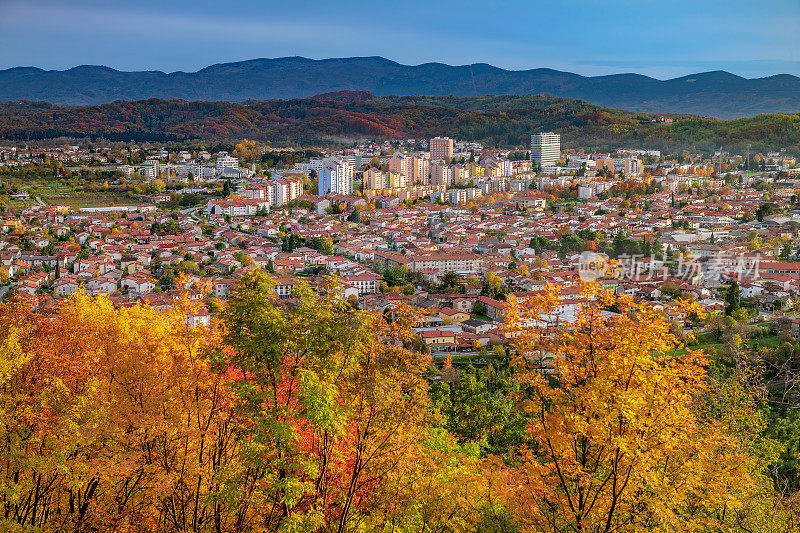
[0,132,800,363]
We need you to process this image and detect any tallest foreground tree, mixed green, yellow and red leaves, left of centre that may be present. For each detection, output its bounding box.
[214,271,476,532]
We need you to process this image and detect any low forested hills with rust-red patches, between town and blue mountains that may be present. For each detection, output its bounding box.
[0,91,800,153]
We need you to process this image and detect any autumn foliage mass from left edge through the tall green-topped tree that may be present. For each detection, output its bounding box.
[0,276,477,531]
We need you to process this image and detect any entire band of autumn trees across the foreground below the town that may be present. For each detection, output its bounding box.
[0,272,797,533]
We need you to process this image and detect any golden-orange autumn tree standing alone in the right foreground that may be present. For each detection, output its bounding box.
[494,291,751,533]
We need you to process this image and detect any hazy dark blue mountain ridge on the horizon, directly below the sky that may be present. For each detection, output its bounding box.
[0,57,800,118]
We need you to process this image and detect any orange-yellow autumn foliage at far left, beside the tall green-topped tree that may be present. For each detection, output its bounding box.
[0,293,236,531]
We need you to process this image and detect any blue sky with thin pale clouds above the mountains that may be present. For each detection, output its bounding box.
[0,0,800,79]
